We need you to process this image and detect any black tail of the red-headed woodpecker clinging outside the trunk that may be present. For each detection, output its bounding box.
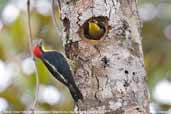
[68,83,83,102]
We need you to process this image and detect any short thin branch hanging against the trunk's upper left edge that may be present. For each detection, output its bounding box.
[51,0,62,38]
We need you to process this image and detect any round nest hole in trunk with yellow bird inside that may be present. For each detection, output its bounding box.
[78,16,108,46]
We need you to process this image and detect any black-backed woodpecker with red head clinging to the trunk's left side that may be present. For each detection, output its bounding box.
[33,41,83,102]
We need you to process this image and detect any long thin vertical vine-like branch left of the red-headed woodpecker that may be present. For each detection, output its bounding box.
[27,0,39,110]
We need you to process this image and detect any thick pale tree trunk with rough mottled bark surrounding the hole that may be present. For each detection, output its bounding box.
[58,0,149,114]
